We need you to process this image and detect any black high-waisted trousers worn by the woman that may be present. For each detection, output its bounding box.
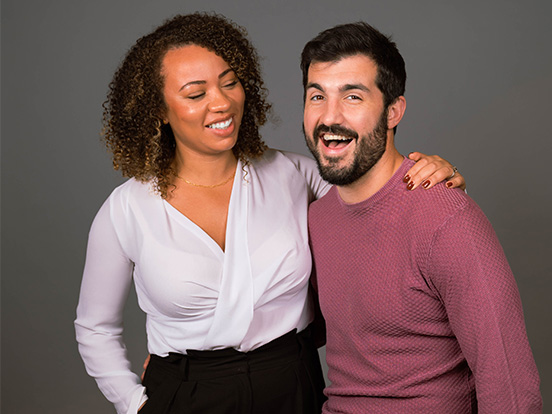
[140,328,325,414]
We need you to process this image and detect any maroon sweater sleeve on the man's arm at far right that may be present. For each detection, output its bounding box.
[427,200,542,414]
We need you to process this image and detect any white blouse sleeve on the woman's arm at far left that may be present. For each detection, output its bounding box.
[75,198,147,414]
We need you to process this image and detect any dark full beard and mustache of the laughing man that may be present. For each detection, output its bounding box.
[303,108,387,186]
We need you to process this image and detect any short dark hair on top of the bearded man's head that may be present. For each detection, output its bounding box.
[301,22,406,108]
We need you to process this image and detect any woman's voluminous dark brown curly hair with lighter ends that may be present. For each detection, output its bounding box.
[103,13,271,198]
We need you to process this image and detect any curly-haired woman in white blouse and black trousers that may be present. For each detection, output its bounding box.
[75,13,463,414]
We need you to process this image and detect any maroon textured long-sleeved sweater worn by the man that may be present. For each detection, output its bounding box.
[309,160,542,414]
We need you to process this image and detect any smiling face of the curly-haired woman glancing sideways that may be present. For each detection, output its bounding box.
[161,45,245,155]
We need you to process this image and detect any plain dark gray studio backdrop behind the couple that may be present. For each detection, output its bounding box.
[1,0,552,414]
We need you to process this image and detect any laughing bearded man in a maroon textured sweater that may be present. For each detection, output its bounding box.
[301,23,542,414]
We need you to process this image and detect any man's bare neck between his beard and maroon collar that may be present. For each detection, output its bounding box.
[337,146,404,204]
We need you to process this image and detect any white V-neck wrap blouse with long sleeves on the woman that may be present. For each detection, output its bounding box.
[75,150,329,413]
